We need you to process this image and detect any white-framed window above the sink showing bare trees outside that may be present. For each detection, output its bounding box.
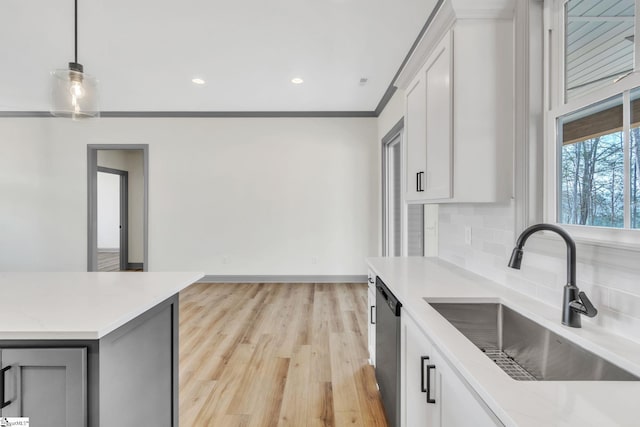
[545,0,640,243]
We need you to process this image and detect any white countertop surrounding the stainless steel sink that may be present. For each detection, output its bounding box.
[367,257,640,427]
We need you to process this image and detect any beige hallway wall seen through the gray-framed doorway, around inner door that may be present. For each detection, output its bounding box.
[98,150,144,263]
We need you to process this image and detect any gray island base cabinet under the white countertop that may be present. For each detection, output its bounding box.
[0,295,178,427]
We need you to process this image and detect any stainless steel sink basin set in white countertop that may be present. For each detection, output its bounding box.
[425,299,640,381]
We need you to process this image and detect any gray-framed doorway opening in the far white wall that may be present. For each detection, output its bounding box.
[87,144,149,271]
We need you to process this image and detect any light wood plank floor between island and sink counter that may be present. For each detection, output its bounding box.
[180,284,386,427]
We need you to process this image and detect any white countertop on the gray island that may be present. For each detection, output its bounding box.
[0,272,203,340]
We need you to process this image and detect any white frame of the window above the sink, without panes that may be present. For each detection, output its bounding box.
[543,0,640,250]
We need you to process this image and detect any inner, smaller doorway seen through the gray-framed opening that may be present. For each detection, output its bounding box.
[96,167,129,271]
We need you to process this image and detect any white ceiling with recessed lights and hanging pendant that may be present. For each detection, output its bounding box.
[0,0,436,112]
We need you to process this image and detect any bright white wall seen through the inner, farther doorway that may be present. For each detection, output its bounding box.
[97,172,120,249]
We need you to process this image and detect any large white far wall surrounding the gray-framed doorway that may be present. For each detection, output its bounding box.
[0,118,379,275]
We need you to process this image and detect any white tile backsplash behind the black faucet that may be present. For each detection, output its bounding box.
[438,202,640,342]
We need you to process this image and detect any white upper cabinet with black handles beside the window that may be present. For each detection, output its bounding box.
[396,1,514,203]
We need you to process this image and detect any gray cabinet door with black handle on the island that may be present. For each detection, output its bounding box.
[0,348,87,427]
